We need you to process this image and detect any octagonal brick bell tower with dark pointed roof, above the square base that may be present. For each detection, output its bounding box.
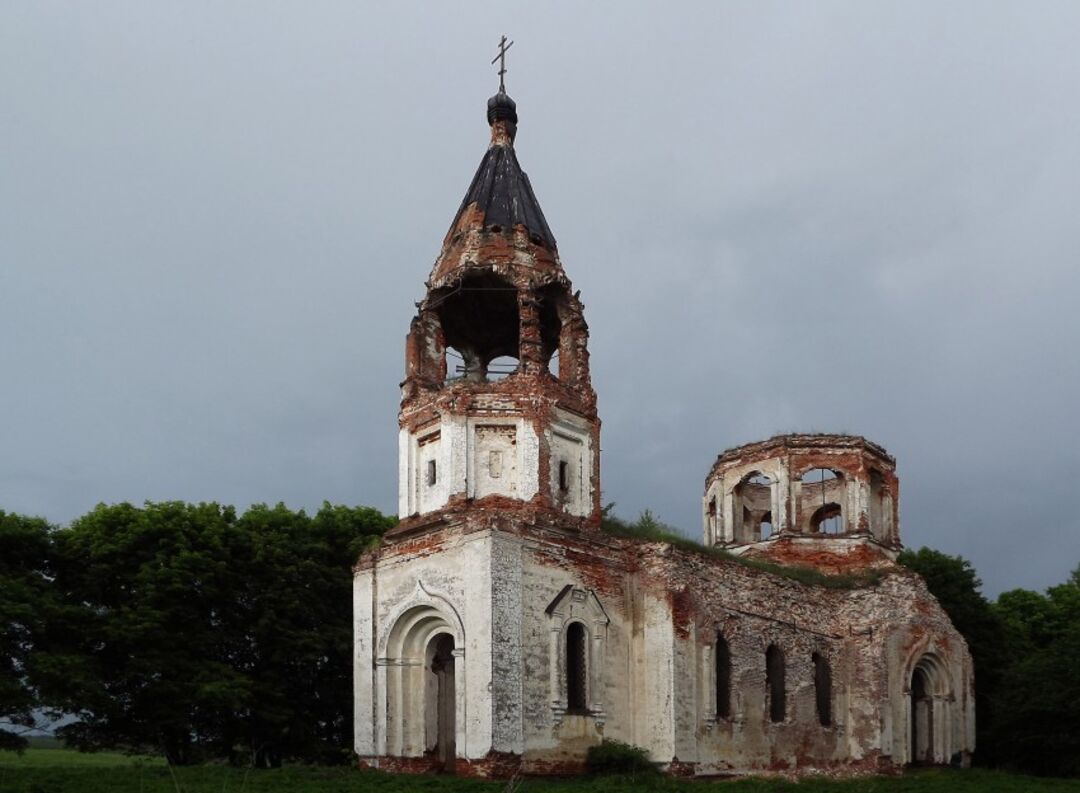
[399,86,600,530]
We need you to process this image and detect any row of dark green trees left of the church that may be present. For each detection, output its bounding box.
[0,501,395,767]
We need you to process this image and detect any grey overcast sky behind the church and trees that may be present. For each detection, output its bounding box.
[0,0,1080,595]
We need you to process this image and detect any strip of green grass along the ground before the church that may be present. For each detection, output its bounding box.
[0,742,1080,793]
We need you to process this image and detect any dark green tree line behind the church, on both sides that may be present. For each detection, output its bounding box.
[0,501,1080,776]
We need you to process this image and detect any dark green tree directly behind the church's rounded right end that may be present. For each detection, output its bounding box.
[897,548,1009,765]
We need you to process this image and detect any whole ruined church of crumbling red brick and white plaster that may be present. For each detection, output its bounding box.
[353,83,974,776]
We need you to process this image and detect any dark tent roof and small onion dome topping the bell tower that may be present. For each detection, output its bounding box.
[450,92,555,251]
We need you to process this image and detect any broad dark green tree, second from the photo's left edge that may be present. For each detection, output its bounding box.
[43,501,249,765]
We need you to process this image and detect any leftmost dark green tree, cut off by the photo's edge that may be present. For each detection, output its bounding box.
[0,511,52,750]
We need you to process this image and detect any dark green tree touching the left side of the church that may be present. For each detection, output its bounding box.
[228,503,394,766]
